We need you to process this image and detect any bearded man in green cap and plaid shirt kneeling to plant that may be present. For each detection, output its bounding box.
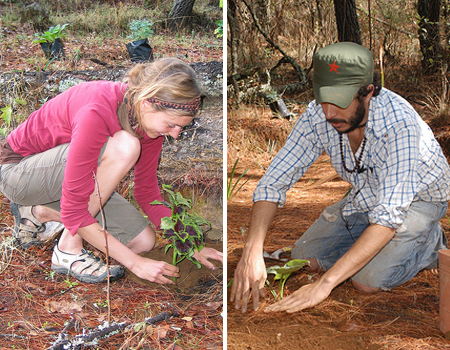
[230,42,450,312]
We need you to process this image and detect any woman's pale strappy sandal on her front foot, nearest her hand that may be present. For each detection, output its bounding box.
[52,242,125,283]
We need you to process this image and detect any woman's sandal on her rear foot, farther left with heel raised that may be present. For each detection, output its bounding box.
[10,202,64,250]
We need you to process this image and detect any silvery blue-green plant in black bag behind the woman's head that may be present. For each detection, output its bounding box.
[126,19,153,62]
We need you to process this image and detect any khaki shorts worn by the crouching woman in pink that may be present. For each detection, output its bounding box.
[0,143,149,244]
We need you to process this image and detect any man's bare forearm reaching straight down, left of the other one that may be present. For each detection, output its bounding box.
[243,201,278,255]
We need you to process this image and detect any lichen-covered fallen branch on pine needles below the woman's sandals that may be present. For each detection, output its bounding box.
[47,311,178,350]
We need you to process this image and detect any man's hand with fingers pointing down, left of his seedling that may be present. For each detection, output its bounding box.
[230,254,267,312]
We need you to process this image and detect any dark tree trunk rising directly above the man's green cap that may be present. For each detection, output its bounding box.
[334,0,362,45]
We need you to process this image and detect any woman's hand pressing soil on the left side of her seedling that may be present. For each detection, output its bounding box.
[131,255,180,284]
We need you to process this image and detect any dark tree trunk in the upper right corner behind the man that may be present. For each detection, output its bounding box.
[417,0,441,74]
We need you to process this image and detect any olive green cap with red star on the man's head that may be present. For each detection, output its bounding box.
[313,42,373,108]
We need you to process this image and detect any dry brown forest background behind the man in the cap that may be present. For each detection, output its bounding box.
[227,0,450,103]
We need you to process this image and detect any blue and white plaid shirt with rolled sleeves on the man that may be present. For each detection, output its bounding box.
[253,89,450,228]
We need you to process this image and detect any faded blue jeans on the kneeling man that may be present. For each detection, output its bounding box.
[291,198,447,290]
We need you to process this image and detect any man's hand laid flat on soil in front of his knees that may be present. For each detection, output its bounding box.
[264,279,333,313]
